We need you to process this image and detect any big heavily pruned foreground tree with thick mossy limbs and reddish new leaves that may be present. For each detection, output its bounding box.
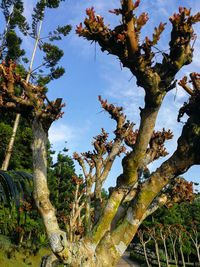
[0,0,200,266]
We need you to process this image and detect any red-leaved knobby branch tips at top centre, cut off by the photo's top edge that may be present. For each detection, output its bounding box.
[76,0,165,65]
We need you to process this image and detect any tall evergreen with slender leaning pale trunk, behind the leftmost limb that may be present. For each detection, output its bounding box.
[1,0,71,171]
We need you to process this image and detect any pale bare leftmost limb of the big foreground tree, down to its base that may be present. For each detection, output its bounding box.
[32,120,99,267]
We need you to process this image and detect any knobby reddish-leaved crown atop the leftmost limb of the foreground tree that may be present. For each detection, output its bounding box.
[0,60,65,130]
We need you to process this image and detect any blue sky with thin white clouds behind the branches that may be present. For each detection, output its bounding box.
[1,0,200,193]
